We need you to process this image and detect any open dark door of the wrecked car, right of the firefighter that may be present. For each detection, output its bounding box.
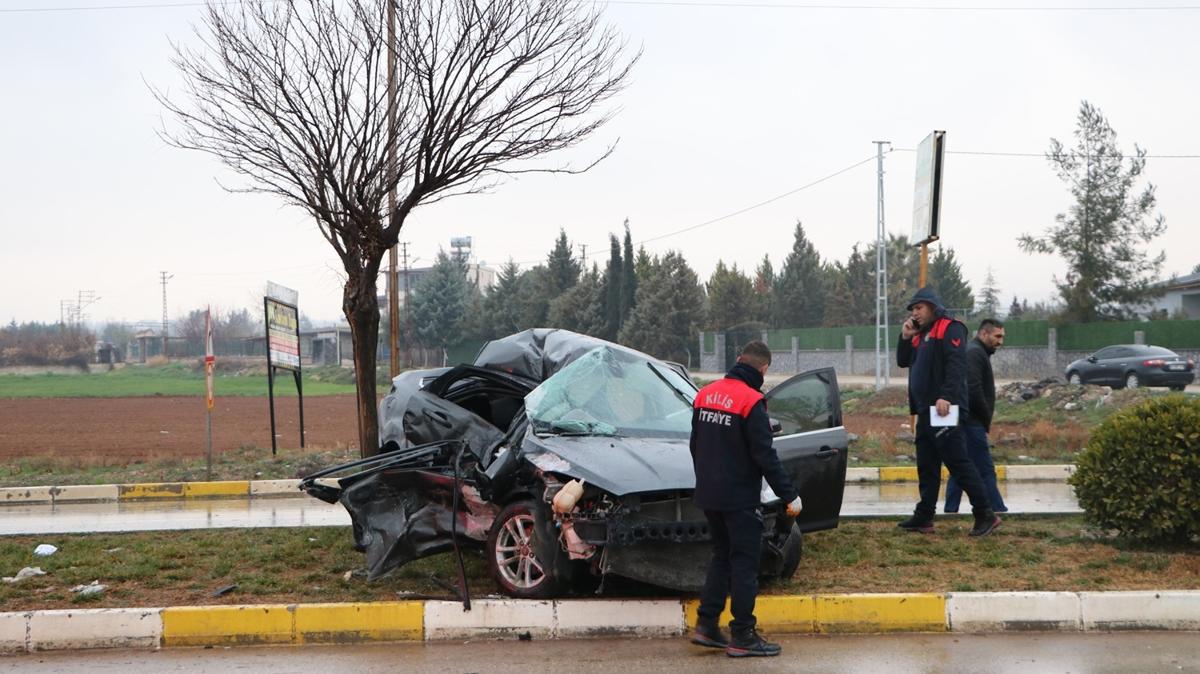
[767,367,850,531]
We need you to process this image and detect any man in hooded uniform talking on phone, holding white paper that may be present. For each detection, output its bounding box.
[896,288,1000,536]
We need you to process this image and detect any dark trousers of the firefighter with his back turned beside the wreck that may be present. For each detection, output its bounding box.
[697,508,762,633]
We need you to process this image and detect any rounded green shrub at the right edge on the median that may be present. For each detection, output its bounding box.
[1070,395,1200,542]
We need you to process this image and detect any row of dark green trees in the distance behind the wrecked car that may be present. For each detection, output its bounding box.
[412,221,1000,362]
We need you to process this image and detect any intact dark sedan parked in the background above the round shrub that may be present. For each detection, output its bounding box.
[1066,344,1195,391]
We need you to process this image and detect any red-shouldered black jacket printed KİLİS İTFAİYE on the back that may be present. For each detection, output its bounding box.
[691,363,797,511]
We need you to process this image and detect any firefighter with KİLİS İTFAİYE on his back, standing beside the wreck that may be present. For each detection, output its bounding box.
[691,342,800,657]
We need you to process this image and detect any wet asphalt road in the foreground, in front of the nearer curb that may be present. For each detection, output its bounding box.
[9,632,1200,674]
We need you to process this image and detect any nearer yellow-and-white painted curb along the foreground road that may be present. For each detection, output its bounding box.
[0,590,1200,652]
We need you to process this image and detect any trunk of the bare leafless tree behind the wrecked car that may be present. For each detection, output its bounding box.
[342,263,379,458]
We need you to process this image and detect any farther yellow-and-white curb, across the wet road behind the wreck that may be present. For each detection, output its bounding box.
[0,465,1075,507]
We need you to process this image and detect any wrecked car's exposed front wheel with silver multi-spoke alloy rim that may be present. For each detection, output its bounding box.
[486,500,562,600]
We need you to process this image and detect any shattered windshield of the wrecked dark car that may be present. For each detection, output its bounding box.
[526,347,696,438]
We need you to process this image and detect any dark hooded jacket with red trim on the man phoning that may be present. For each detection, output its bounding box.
[896,288,970,420]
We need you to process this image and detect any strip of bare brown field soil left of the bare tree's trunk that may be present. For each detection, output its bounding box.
[0,396,358,463]
